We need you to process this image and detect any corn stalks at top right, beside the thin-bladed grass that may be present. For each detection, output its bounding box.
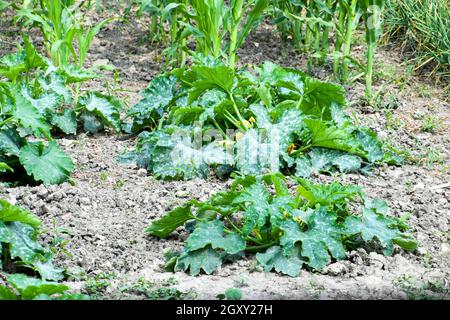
[272,0,384,98]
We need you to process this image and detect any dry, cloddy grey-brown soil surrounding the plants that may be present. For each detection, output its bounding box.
[0,10,450,299]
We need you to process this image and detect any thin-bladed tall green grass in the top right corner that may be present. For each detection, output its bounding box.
[385,0,450,81]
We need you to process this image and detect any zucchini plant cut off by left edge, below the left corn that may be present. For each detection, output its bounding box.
[0,35,122,184]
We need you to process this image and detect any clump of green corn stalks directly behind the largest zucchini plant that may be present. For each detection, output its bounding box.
[137,0,270,66]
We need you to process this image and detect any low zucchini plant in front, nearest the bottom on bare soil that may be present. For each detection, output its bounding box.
[146,174,417,277]
